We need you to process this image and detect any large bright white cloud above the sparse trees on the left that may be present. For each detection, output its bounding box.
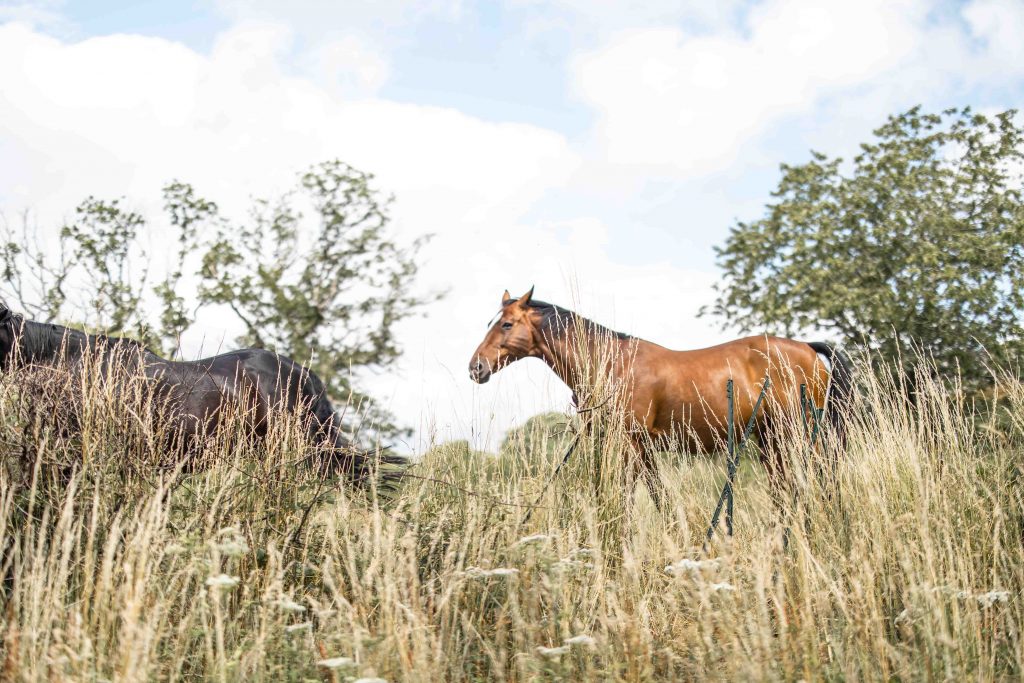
[0,20,578,222]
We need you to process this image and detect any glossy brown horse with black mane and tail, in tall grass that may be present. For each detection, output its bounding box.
[469,289,852,497]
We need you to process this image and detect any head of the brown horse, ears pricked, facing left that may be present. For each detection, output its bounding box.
[469,288,544,384]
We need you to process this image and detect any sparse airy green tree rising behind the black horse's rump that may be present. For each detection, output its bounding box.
[179,161,437,437]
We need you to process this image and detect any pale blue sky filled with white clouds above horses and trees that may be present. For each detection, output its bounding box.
[0,0,1024,447]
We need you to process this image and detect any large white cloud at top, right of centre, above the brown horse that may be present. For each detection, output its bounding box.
[572,0,923,174]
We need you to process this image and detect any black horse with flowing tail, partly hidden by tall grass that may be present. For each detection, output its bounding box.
[0,303,402,483]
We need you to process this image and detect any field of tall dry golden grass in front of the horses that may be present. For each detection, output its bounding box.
[0,360,1024,682]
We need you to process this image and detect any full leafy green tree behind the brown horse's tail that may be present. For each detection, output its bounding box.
[702,108,1024,386]
